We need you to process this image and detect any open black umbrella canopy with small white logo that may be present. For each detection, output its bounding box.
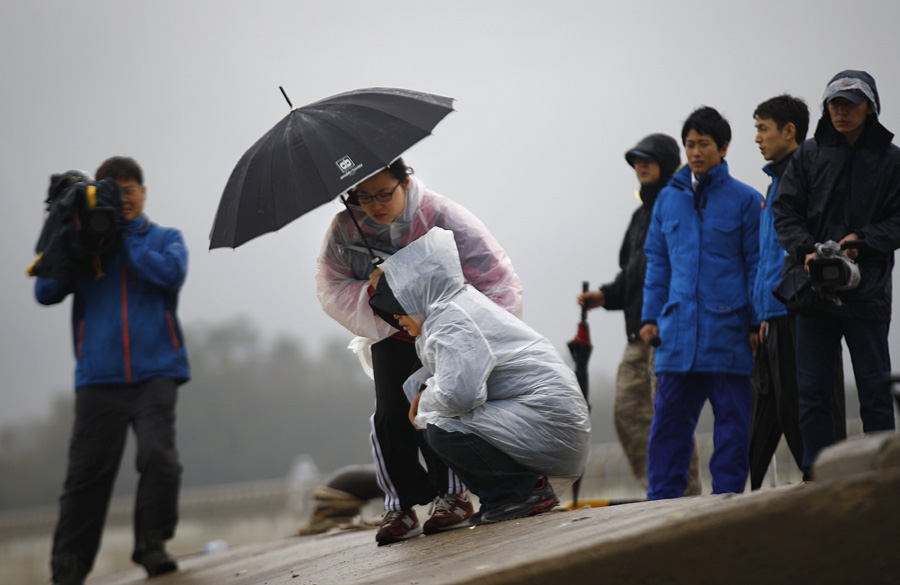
[209,88,453,249]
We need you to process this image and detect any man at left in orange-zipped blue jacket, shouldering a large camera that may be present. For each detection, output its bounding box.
[35,157,190,585]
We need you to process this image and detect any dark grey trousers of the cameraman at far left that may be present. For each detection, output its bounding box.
[52,378,181,574]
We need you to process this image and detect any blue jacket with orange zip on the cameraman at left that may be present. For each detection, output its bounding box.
[34,216,191,387]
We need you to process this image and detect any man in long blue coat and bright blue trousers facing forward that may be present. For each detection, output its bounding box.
[641,107,762,500]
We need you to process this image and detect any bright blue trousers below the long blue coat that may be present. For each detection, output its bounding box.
[647,372,751,500]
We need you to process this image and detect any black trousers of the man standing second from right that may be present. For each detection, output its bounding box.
[750,315,847,490]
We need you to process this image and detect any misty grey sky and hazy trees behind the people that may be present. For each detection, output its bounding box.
[0,0,900,506]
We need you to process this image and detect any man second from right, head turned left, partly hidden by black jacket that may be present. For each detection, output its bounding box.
[750,94,847,490]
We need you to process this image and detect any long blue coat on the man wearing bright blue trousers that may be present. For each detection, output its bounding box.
[643,161,763,375]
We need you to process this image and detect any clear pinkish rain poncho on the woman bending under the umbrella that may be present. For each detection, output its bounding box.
[316,176,522,341]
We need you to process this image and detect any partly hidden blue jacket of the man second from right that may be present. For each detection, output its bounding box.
[753,153,793,321]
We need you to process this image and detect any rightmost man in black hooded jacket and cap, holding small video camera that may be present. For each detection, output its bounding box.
[773,70,900,479]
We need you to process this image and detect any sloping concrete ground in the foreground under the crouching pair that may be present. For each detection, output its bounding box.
[88,435,900,585]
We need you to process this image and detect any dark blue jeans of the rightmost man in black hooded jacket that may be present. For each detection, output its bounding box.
[797,314,894,475]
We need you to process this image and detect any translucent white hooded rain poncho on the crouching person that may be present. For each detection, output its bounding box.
[382,228,590,480]
